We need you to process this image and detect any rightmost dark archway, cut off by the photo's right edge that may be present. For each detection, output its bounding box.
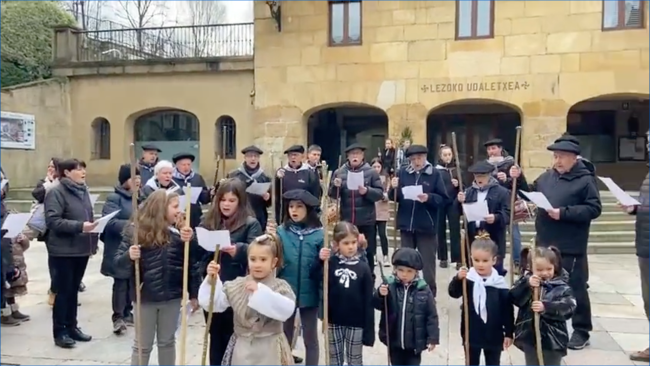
[567,94,650,190]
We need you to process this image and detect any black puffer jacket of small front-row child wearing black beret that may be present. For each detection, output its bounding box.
[373,277,440,353]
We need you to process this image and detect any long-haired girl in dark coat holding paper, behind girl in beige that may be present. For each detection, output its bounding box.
[199,179,263,365]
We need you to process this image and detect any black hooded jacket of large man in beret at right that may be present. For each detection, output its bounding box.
[530,159,602,255]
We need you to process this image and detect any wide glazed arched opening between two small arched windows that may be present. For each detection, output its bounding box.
[133,109,200,168]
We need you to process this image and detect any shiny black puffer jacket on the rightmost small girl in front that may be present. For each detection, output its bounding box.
[510,270,576,356]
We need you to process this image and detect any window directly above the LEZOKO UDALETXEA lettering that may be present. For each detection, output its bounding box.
[456,0,494,39]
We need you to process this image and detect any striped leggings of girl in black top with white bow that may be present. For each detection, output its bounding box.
[328,324,363,366]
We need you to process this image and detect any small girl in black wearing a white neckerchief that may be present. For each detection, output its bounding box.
[449,233,514,365]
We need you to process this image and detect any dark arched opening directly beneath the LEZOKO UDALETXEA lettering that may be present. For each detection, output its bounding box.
[427,99,521,182]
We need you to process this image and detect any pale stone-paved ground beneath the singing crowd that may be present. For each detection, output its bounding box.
[1,242,649,365]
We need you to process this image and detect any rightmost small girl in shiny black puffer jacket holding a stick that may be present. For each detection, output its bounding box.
[510,246,576,365]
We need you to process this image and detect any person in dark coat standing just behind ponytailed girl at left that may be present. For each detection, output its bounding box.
[100,164,140,334]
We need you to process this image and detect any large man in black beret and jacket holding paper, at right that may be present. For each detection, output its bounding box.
[510,139,602,349]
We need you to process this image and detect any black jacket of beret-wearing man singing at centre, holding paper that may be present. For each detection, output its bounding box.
[328,162,384,226]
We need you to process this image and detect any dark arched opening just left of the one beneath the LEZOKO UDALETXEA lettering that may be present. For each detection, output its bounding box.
[306,104,389,170]
